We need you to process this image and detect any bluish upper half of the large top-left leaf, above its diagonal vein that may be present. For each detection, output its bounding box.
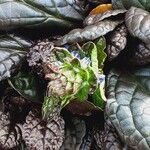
[22,0,83,20]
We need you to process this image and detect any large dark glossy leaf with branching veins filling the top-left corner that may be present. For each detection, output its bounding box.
[0,0,85,30]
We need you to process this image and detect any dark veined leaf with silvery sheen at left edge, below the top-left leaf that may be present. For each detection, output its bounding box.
[0,35,31,81]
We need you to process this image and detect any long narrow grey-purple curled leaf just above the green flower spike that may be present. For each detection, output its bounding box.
[55,20,122,45]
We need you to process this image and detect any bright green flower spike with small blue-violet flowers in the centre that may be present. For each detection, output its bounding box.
[43,38,106,117]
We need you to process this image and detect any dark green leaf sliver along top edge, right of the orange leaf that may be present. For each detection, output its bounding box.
[112,0,150,11]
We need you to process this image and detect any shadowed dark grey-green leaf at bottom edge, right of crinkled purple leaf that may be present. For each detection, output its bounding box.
[60,117,92,150]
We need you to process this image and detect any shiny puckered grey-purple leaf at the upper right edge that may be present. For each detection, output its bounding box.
[125,7,150,48]
